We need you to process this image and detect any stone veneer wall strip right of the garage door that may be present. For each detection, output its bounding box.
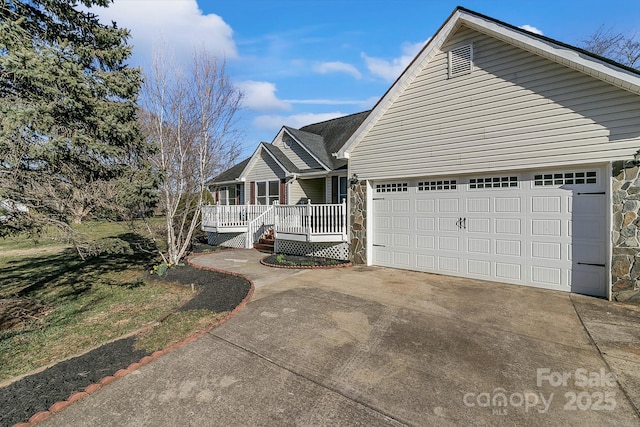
[611,161,640,303]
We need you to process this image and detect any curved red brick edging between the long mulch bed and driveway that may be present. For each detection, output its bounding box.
[13,260,255,427]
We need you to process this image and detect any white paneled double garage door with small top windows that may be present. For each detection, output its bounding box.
[372,168,608,296]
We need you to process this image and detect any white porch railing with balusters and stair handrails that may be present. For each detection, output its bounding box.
[202,201,347,248]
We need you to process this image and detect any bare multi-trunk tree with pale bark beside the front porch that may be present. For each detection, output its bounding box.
[140,51,243,263]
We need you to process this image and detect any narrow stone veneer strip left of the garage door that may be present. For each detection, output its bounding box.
[349,181,367,265]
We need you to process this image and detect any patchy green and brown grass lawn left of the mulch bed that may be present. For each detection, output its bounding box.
[0,222,204,382]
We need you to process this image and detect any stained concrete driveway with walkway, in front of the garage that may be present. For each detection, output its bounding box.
[43,251,640,426]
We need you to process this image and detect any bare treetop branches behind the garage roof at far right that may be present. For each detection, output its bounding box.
[581,26,640,68]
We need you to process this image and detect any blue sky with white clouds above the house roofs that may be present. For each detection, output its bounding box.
[96,0,640,158]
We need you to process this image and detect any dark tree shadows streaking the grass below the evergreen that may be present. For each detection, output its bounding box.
[0,233,157,300]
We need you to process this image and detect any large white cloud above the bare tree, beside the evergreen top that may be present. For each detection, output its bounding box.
[91,0,238,63]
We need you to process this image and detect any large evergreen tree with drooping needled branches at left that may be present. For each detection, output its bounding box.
[0,0,156,235]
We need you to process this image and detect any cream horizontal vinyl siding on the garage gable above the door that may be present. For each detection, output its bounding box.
[349,27,640,179]
